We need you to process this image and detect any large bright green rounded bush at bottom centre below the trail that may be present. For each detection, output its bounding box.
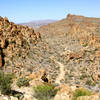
[34,84,58,100]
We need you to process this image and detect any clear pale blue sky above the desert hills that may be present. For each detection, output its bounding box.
[0,0,100,23]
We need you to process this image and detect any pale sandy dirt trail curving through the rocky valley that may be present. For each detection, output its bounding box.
[54,60,65,84]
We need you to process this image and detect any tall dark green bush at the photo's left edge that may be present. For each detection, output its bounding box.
[0,71,13,94]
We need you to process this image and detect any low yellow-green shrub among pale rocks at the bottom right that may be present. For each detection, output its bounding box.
[73,88,91,100]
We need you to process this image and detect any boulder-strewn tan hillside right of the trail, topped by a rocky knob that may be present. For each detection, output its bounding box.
[39,14,100,91]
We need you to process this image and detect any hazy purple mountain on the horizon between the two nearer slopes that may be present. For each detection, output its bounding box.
[20,20,57,28]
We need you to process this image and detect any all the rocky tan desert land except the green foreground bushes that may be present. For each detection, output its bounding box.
[0,14,100,100]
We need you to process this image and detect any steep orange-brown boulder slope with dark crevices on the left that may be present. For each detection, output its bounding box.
[0,17,39,72]
